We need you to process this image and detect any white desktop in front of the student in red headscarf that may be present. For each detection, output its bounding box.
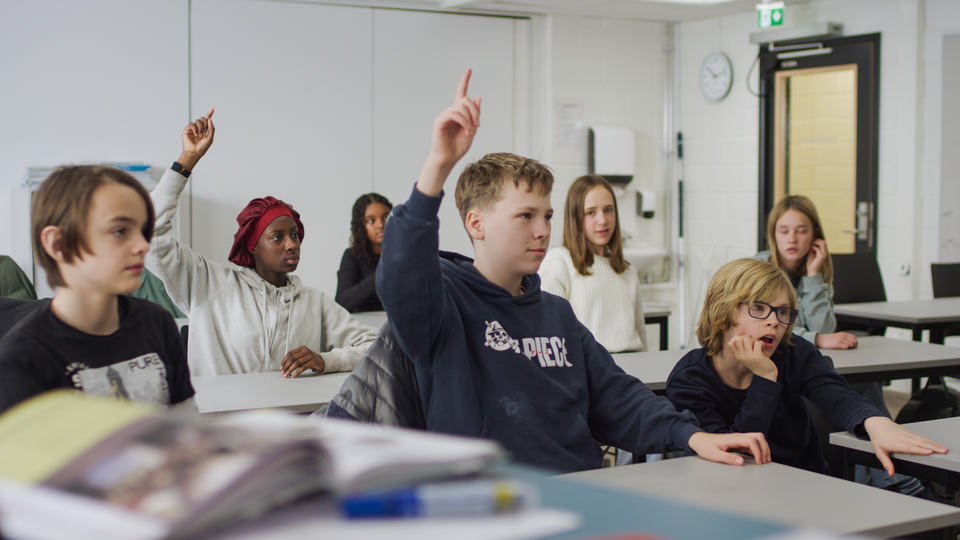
[191,371,350,416]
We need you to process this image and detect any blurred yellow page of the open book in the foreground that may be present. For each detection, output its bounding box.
[0,390,156,484]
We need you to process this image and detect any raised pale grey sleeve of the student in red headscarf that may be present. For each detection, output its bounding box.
[145,169,232,317]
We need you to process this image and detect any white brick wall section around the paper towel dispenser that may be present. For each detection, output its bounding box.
[533,15,669,255]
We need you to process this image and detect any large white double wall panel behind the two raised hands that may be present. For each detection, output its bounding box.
[190,0,515,297]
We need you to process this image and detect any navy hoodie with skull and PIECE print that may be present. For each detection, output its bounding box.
[377,188,699,472]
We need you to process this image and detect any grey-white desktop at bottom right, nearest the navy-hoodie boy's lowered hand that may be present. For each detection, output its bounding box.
[559,456,960,538]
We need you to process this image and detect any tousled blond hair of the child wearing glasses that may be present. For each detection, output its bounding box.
[697,259,797,356]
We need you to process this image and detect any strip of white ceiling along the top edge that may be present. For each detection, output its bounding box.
[337,0,806,22]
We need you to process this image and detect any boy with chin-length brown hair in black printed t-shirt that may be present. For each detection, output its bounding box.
[0,166,196,411]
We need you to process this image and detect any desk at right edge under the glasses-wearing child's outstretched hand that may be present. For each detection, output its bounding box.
[830,417,960,489]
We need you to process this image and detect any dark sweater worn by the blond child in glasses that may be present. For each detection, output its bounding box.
[667,339,880,474]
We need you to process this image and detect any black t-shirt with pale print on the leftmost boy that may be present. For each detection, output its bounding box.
[0,296,194,412]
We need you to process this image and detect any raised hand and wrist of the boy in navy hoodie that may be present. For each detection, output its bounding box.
[417,69,482,196]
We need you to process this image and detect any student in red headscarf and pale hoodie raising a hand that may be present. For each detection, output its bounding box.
[146,109,377,377]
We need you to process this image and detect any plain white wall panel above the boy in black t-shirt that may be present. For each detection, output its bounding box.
[0,0,189,286]
